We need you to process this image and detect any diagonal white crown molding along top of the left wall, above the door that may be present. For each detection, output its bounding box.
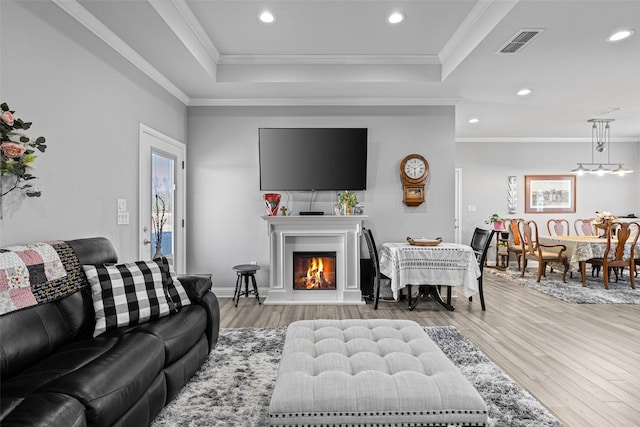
[52,0,189,105]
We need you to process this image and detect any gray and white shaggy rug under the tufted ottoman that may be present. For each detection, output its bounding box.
[152,326,559,427]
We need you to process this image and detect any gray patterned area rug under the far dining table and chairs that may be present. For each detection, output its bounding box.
[484,267,640,304]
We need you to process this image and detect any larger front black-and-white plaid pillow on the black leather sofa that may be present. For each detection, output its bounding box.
[83,261,170,337]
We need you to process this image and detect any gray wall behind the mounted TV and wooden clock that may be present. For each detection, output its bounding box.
[187,107,455,287]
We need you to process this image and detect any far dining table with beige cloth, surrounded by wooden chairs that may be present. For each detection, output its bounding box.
[538,236,640,286]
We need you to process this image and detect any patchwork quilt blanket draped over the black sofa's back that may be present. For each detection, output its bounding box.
[0,241,86,315]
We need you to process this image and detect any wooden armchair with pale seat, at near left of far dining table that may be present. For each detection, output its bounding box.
[520,220,569,283]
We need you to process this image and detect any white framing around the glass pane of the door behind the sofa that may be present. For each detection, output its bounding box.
[138,123,187,273]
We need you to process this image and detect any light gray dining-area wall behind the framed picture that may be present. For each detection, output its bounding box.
[456,140,640,261]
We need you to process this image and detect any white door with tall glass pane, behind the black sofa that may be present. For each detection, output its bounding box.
[139,124,186,273]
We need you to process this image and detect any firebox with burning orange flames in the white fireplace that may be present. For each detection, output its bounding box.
[293,252,336,290]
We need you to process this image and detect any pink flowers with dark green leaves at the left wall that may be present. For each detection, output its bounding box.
[0,103,47,197]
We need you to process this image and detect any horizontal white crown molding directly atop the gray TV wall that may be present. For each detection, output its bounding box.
[189,97,460,107]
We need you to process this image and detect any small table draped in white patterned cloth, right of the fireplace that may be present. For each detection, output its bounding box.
[379,242,481,311]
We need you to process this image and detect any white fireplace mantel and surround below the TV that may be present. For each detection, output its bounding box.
[262,215,367,305]
